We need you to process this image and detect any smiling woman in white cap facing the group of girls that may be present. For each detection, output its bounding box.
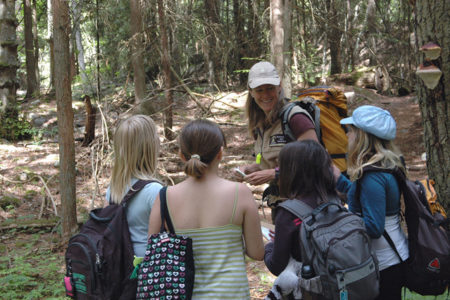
[234,61,318,218]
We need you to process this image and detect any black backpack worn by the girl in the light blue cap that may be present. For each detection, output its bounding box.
[355,166,450,295]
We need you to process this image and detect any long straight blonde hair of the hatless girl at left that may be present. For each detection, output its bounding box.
[110,115,159,203]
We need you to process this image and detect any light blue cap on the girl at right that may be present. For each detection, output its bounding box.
[340,105,397,141]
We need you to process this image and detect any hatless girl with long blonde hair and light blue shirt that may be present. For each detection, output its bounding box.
[106,115,162,257]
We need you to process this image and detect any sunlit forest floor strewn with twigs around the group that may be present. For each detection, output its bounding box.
[0,86,427,299]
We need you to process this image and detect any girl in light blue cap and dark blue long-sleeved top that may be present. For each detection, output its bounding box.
[334,105,409,300]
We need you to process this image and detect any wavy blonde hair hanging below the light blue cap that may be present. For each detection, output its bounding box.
[347,125,406,181]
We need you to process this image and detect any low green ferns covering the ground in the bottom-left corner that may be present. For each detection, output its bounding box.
[0,250,66,299]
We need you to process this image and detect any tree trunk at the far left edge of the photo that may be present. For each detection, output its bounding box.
[0,0,19,131]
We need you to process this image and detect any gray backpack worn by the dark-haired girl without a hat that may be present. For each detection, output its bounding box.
[280,199,380,300]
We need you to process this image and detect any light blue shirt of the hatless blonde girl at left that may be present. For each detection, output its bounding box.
[106,178,162,257]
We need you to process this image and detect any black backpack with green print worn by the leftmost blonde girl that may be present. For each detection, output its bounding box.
[64,180,153,299]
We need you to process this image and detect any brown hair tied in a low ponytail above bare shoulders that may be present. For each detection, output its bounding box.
[178,119,226,178]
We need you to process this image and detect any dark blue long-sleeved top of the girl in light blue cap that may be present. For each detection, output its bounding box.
[337,172,400,238]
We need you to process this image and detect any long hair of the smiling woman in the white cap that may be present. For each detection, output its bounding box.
[245,87,285,139]
